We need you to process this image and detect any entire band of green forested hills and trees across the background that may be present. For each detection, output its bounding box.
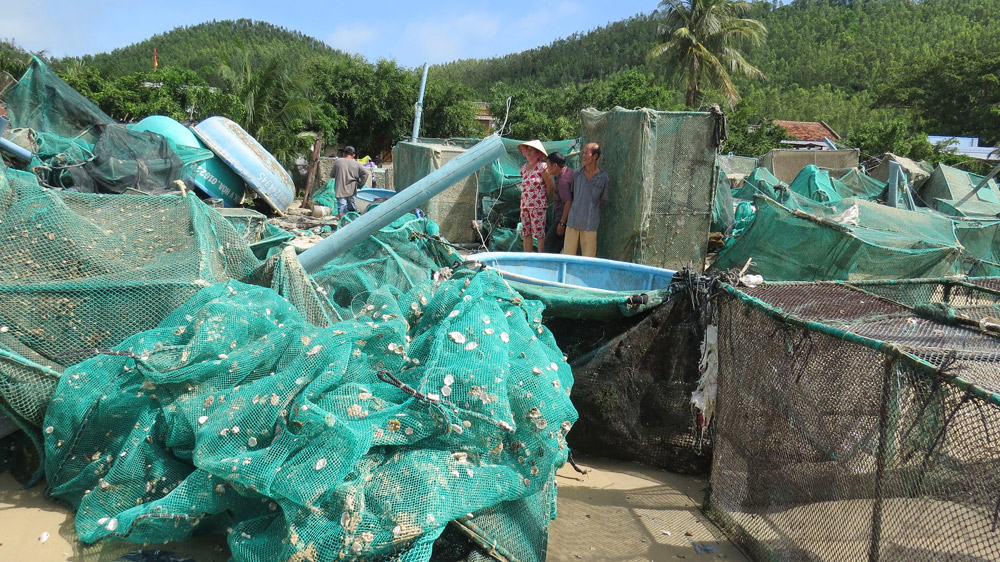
[0,0,1000,159]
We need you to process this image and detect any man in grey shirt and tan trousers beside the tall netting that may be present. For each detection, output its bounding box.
[563,142,608,258]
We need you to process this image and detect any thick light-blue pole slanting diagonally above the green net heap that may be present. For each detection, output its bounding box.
[299,134,506,273]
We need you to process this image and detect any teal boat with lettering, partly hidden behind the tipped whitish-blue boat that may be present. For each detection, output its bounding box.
[133,115,246,207]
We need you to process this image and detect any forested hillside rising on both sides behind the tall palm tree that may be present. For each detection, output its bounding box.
[435,0,1000,98]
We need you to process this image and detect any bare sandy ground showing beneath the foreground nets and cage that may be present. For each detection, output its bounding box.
[0,459,747,562]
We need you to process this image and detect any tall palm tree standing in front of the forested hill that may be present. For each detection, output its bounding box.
[649,0,767,108]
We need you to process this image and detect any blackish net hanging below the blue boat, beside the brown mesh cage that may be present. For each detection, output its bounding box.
[564,284,712,474]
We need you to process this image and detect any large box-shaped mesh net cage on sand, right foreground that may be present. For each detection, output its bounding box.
[704,278,1000,562]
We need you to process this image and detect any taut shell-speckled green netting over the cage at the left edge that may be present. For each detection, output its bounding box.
[0,165,259,364]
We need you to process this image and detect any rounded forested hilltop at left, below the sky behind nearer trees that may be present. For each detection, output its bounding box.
[83,19,347,77]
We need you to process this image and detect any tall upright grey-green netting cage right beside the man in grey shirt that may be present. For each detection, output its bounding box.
[582,108,718,269]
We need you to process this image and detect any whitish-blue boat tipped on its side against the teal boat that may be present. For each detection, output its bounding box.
[194,116,295,214]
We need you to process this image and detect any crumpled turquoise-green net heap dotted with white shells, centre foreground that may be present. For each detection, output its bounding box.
[44,271,576,561]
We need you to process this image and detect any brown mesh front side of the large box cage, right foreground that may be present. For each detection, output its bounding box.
[710,295,1000,562]
